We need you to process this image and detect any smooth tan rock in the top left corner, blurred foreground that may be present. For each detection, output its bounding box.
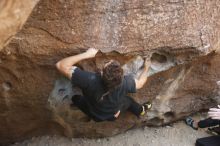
[0,0,39,50]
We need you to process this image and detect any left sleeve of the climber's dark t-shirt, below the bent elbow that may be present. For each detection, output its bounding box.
[71,66,92,89]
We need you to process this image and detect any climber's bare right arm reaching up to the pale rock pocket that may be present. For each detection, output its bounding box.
[135,60,150,89]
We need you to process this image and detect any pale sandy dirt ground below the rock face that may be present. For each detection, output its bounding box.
[12,116,211,146]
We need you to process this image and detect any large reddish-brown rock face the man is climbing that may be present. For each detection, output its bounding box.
[0,0,220,144]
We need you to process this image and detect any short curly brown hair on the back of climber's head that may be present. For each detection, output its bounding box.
[102,60,123,90]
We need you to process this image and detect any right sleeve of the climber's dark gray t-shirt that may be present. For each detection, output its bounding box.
[124,75,136,93]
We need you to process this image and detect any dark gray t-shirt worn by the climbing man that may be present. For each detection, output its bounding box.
[71,68,136,120]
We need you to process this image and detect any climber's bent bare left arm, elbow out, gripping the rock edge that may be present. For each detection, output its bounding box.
[56,48,98,79]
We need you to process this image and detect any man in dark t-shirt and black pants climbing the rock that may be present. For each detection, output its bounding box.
[56,48,151,122]
